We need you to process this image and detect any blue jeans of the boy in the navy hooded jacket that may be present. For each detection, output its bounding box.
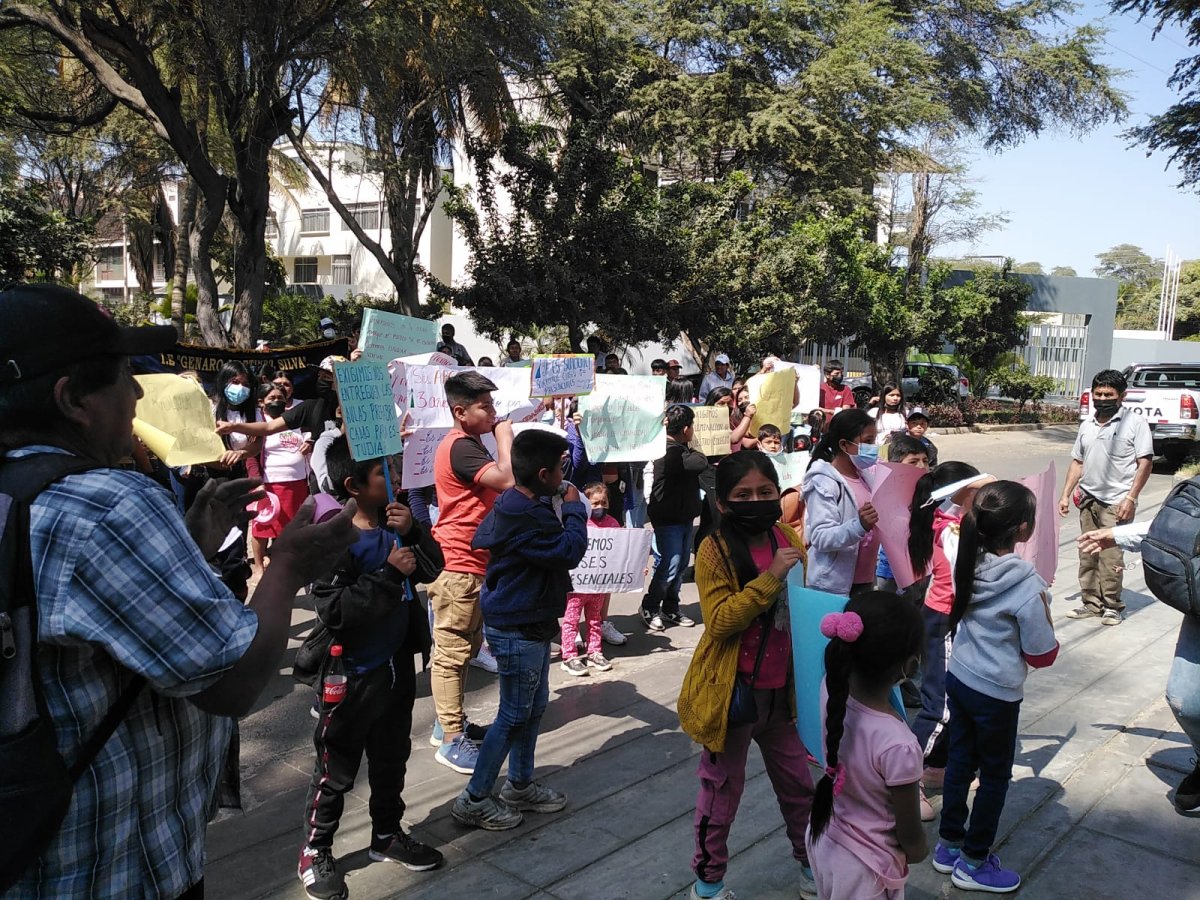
[467,625,550,797]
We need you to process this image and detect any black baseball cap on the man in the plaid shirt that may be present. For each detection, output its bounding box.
[0,284,179,385]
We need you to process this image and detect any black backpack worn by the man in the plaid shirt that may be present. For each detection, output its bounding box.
[0,454,145,894]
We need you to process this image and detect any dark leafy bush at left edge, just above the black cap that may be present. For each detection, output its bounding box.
[0,182,92,284]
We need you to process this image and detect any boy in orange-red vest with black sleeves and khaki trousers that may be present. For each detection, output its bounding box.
[428,372,512,775]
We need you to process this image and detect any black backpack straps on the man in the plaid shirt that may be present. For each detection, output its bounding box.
[0,454,146,784]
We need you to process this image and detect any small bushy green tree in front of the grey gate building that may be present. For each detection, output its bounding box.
[946,259,1033,396]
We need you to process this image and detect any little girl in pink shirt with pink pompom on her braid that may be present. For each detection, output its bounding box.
[808,590,929,900]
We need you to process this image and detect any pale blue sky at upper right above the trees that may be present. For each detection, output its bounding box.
[935,2,1200,275]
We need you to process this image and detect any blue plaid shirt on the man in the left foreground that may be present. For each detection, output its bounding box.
[5,446,258,900]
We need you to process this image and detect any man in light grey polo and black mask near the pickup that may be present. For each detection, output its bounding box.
[1058,368,1154,625]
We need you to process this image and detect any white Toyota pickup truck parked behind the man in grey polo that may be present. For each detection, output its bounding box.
[1079,362,1200,463]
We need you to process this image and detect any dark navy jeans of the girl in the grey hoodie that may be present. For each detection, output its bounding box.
[940,673,1021,862]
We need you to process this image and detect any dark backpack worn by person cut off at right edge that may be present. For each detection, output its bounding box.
[1141,479,1200,616]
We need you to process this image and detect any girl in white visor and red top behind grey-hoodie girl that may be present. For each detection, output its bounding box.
[908,462,992,822]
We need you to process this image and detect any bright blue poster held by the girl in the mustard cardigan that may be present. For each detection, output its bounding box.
[787,564,905,768]
